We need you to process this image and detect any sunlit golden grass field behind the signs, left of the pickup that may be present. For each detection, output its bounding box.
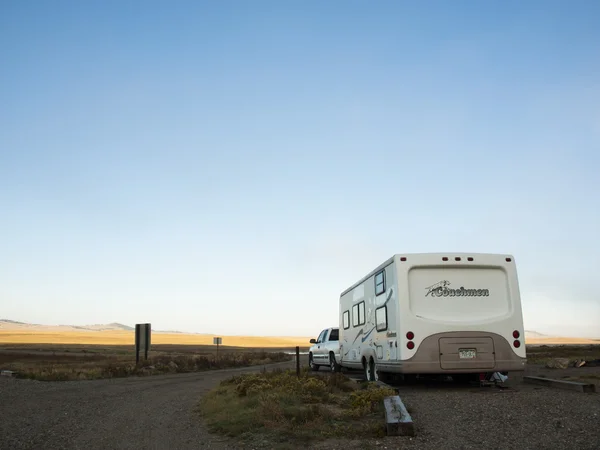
[0,330,311,349]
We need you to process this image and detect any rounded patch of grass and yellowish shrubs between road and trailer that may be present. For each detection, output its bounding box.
[199,370,396,448]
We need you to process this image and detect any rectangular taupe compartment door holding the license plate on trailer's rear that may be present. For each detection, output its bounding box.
[440,337,496,370]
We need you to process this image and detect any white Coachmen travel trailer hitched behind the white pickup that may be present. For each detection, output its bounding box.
[336,253,526,380]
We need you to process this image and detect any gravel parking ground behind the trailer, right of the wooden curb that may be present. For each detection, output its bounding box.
[317,379,600,450]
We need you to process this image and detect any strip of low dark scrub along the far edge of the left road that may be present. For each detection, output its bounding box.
[0,351,291,381]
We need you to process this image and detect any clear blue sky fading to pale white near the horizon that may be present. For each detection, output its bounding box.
[0,0,600,336]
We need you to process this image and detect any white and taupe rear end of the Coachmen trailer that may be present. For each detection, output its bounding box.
[394,254,526,374]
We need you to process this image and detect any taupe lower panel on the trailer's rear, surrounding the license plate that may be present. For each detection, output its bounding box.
[378,331,527,374]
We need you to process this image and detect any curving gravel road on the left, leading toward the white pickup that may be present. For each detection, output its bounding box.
[0,362,294,450]
